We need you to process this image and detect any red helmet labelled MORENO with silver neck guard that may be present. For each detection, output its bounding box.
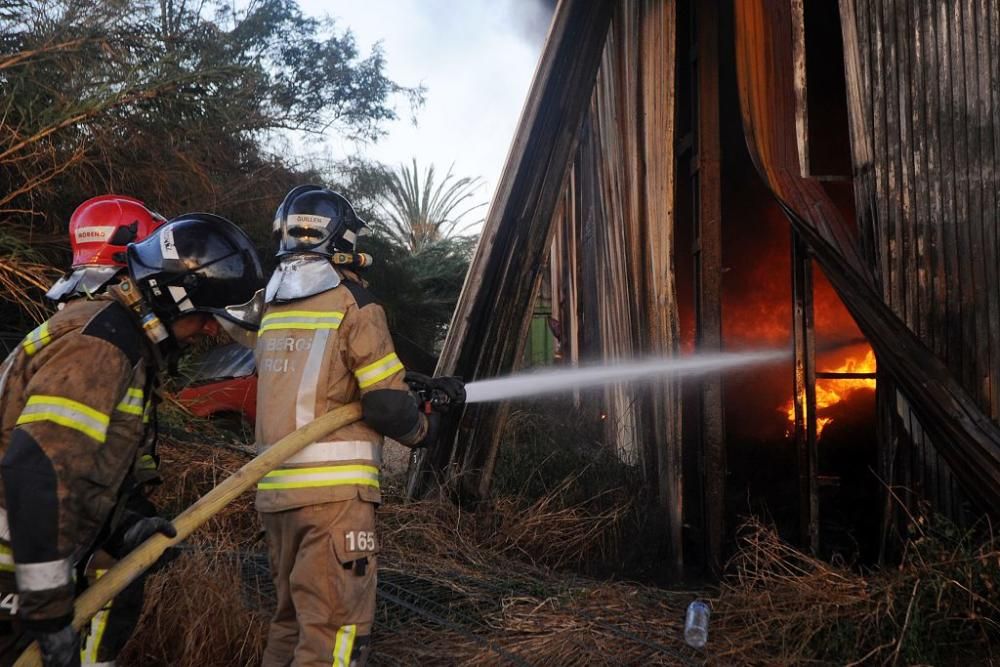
[45,195,166,301]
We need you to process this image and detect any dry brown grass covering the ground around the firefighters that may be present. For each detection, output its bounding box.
[124,425,1000,667]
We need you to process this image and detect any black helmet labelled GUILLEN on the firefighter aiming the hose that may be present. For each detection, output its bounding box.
[274,185,365,257]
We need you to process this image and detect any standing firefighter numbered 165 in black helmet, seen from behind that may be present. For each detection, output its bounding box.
[256,185,464,667]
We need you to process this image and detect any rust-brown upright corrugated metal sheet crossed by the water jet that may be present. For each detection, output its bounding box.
[550,0,682,567]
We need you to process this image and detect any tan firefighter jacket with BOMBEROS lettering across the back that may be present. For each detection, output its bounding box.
[255,278,428,513]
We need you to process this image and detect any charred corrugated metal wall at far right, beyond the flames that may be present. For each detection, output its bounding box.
[841,0,1000,516]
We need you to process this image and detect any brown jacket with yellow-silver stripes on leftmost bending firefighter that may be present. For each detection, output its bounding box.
[0,296,156,629]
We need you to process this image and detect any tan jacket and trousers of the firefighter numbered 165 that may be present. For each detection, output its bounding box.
[256,280,428,667]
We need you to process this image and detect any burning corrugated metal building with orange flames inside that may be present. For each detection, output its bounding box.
[410,0,1000,571]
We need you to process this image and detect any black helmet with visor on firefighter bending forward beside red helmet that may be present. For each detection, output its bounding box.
[127,213,264,330]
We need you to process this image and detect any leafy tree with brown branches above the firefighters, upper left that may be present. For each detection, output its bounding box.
[0,0,423,322]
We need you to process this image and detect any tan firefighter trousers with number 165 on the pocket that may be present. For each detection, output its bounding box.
[260,498,378,667]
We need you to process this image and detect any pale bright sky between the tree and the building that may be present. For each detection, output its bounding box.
[299,0,551,200]
